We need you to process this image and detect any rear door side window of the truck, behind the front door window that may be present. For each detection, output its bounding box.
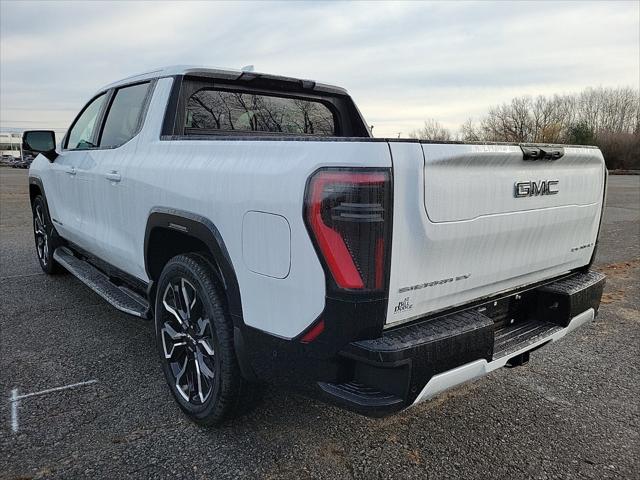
[100,83,150,147]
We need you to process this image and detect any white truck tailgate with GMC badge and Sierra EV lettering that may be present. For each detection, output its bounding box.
[387,142,606,324]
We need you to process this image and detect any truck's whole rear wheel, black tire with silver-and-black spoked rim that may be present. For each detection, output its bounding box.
[155,253,249,425]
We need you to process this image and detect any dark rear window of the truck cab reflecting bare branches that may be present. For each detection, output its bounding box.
[185,89,336,136]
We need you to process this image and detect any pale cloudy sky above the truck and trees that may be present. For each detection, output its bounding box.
[0,0,640,136]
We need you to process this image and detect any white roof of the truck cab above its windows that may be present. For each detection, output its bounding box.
[100,65,347,95]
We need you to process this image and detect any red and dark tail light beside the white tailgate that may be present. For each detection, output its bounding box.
[305,169,391,292]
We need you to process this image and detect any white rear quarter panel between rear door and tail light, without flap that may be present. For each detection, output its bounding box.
[124,79,390,338]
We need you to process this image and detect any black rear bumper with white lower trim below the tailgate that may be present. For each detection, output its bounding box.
[318,272,605,416]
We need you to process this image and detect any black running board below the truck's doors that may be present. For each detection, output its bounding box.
[53,247,150,319]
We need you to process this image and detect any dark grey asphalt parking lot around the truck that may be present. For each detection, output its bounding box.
[0,168,640,479]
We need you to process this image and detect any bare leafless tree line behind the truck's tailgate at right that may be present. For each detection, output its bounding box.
[409,87,640,169]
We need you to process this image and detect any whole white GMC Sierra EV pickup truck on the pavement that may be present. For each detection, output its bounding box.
[23,67,607,424]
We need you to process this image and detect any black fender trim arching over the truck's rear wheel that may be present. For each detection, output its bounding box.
[144,207,244,318]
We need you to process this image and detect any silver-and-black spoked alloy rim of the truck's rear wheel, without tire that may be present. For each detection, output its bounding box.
[160,277,215,405]
